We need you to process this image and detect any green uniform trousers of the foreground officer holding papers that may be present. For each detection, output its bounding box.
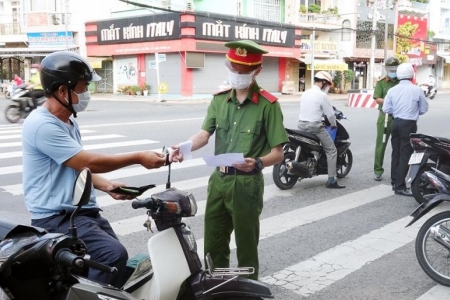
[204,171,264,280]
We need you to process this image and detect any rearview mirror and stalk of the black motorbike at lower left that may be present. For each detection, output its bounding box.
[69,168,92,238]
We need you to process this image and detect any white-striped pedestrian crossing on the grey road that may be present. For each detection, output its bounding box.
[0,125,450,300]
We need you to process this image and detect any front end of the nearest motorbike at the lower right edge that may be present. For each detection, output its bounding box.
[406,168,450,286]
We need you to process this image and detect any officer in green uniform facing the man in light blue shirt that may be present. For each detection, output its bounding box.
[373,56,400,182]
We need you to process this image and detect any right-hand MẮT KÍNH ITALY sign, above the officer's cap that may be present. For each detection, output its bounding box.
[195,16,295,47]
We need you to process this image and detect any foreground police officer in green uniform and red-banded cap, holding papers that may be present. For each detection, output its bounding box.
[170,40,288,280]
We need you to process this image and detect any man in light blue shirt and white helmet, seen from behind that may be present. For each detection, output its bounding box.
[383,63,428,196]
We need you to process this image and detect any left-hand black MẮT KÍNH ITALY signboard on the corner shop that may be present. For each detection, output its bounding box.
[97,13,180,45]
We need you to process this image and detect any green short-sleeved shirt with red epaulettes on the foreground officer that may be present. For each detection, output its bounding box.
[202,82,288,157]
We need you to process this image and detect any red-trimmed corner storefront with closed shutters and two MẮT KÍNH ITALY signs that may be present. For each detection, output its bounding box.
[86,13,301,97]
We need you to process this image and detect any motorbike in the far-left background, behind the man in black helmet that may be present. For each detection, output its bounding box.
[5,83,45,123]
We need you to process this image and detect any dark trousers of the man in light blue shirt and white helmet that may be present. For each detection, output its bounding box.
[391,118,417,191]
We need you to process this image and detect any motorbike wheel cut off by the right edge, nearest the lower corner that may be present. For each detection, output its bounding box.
[416,211,450,286]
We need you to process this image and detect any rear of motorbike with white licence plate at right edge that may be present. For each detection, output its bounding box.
[407,133,450,203]
